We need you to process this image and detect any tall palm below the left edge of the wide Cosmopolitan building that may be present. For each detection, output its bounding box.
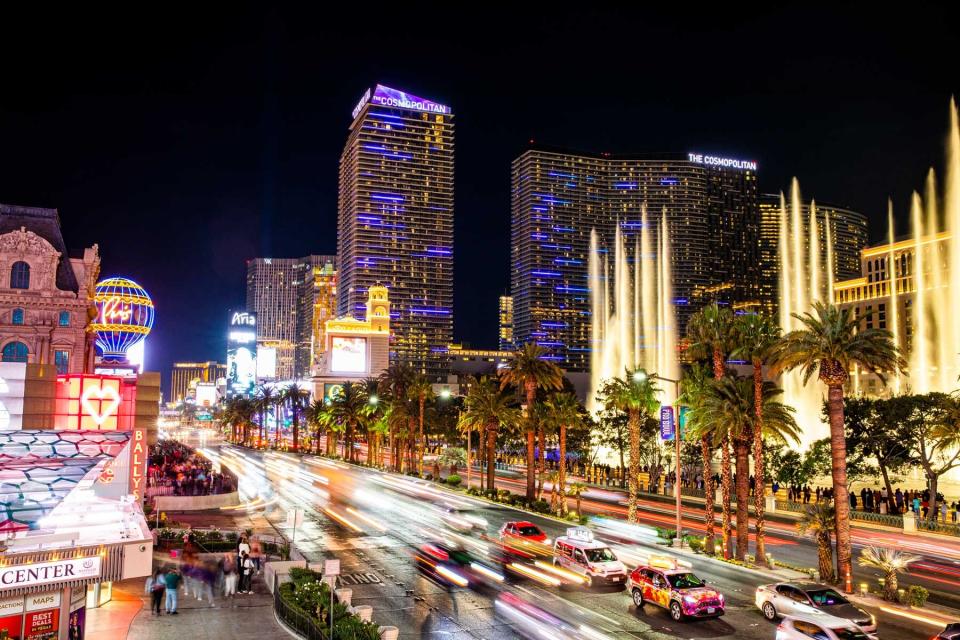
[500,342,563,501]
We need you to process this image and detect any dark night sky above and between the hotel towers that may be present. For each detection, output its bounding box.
[0,3,960,396]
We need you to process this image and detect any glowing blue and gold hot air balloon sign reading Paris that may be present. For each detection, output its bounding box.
[90,278,153,363]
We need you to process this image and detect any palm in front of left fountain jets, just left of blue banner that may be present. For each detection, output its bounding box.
[599,369,660,522]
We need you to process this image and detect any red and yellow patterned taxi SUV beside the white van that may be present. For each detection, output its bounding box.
[627,556,726,622]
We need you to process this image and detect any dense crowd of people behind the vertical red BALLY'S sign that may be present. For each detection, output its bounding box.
[147,440,236,496]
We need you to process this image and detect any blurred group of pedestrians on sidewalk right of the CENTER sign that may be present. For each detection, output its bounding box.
[144,534,264,616]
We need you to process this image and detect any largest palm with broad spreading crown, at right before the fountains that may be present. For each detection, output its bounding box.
[771,302,906,591]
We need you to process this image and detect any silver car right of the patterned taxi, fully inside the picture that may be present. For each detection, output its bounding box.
[754,582,877,633]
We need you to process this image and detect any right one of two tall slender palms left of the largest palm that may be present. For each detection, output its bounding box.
[731,314,780,567]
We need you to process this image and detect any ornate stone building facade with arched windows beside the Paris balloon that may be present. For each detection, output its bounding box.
[0,204,100,373]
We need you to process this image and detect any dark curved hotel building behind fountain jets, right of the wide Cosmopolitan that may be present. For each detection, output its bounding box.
[760,193,867,317]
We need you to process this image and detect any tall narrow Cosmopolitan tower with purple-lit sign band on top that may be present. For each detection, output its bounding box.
[337,85,453,379]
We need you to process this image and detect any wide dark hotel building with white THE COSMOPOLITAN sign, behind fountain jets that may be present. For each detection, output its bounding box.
[510,146,760,371]
